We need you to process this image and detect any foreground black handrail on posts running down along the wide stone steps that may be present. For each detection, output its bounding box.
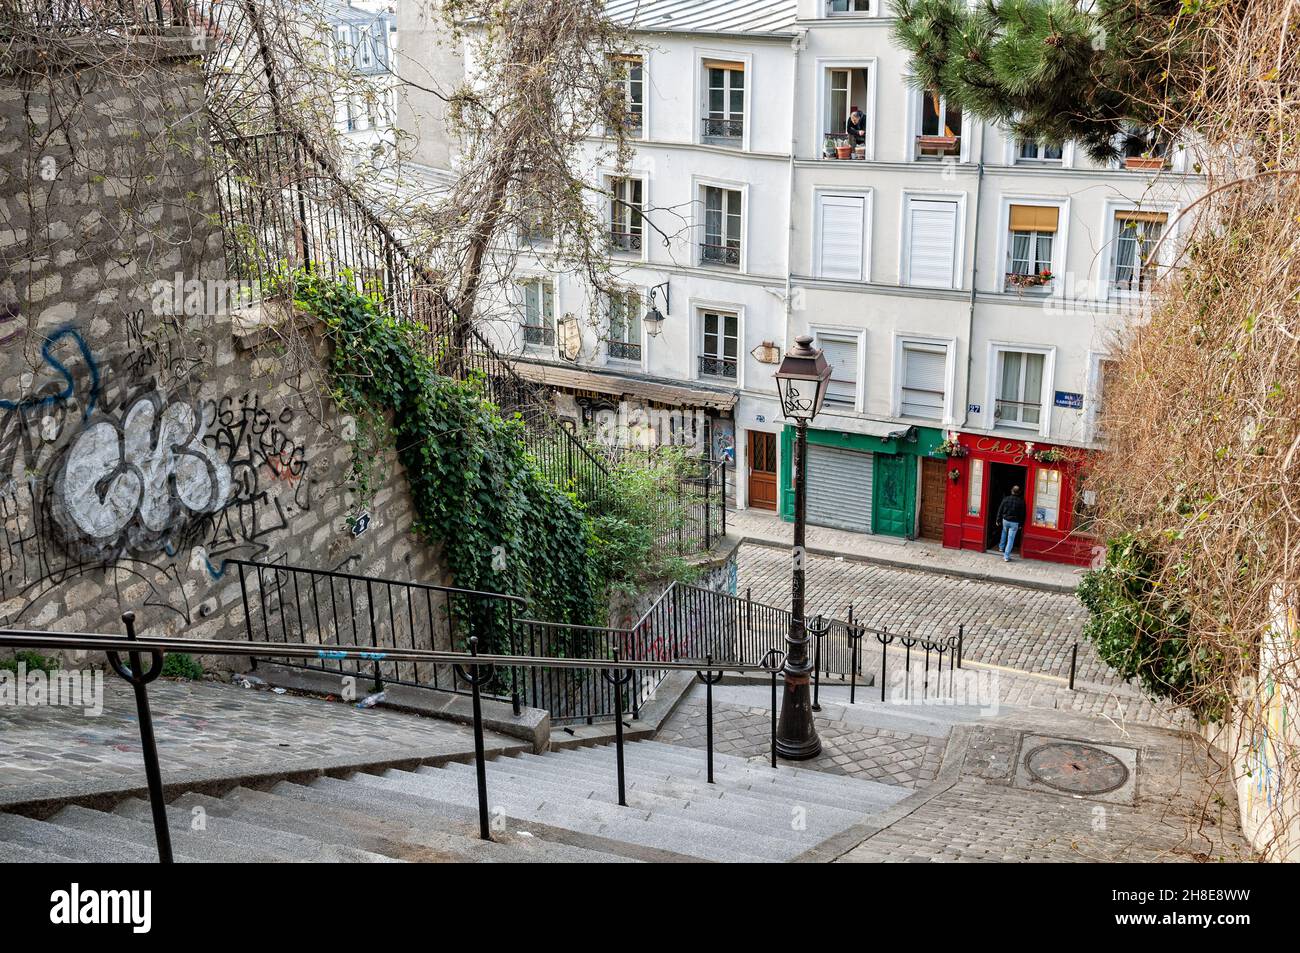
[0,621,783,863]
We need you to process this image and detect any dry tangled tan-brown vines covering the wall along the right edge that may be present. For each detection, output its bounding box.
[1095,0,1300,852]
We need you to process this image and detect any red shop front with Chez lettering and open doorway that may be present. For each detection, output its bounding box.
[944,433,1096,566]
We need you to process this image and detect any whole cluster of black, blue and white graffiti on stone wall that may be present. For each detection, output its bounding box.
[0,312,312,624]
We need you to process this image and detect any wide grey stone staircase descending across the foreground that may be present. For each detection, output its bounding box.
[0,741,911,863]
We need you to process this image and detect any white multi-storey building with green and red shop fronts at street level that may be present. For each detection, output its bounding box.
[460,0,1201,563]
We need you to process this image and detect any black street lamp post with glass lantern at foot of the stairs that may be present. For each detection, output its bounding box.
[776,335,831,761]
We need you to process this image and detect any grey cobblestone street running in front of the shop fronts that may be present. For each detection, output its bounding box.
[738,543,1121,685]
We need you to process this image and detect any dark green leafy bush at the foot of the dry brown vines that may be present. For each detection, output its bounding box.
[1079,534,1226,720]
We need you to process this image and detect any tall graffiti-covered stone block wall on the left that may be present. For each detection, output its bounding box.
[0,35,445,655]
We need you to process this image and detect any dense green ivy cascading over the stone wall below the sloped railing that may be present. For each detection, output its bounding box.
[293,272,598,650]
